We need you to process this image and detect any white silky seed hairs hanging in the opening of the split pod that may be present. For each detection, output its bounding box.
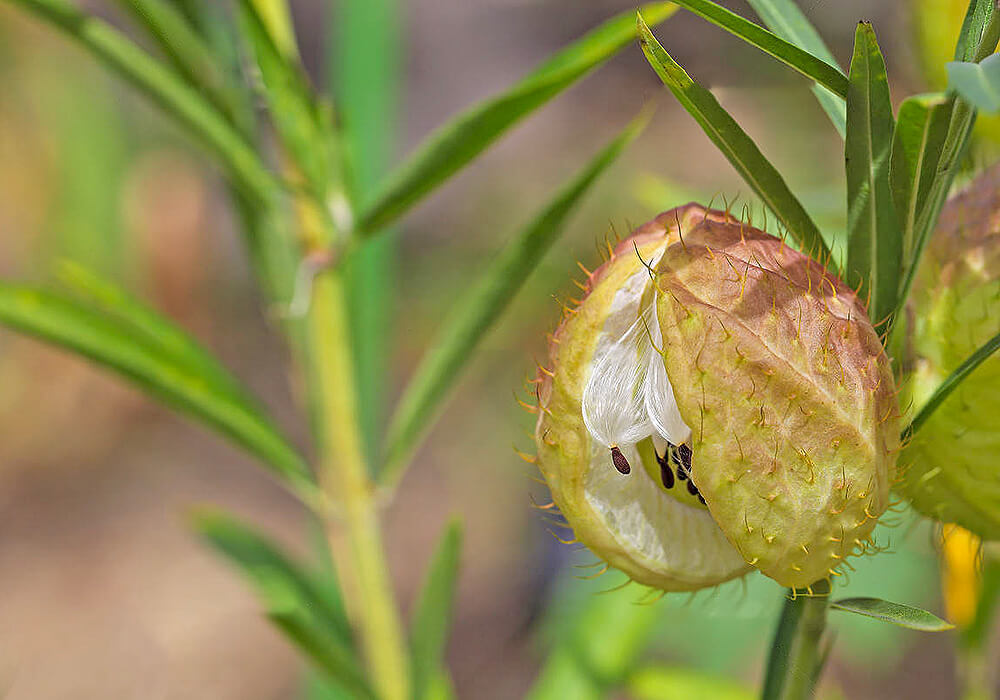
[582,251,691,448]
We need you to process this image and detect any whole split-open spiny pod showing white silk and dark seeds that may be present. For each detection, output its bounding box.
[535,204,899,591]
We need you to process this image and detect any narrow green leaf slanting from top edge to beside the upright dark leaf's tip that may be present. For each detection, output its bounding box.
[674,0,847,99]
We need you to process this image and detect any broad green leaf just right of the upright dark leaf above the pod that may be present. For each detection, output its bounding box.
[889,93,954,261]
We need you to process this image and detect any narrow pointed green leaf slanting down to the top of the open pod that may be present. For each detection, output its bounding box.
[637,14,830,260]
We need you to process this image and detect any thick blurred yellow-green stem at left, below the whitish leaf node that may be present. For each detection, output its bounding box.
[306,269,409,700]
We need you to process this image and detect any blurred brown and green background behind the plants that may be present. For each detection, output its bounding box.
[0,0,984,700]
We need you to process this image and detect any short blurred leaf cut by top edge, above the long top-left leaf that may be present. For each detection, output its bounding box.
[110,0,243,125]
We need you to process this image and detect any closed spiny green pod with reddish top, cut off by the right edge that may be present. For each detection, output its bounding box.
[899,167,1000,539]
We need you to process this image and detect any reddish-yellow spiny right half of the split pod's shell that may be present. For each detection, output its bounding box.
[658,216,900,588]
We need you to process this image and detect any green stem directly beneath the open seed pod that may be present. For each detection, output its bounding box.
[761,581,830,700]
